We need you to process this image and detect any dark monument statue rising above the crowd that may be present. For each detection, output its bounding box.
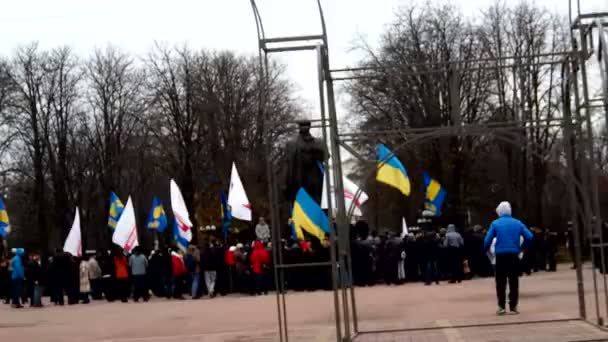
[284,121,328,203]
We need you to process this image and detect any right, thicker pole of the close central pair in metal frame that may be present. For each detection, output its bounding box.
[321,45,351,342]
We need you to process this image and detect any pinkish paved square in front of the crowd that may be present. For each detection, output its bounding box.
[0,265,608,342]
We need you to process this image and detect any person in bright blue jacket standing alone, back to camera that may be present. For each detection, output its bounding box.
[484,202,533,315]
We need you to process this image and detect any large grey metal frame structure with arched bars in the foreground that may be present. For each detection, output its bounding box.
[250,0,608,341]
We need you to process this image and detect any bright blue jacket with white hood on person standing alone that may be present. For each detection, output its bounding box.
[484,202,533,255]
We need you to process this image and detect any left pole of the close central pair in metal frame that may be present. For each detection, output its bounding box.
[317,45,342,341]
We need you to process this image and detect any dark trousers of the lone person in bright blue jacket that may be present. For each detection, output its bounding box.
[496,253,520,310]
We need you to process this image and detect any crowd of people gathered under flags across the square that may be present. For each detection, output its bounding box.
[0,211,559,308]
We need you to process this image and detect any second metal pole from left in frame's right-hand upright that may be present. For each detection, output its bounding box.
[575,30,608,326]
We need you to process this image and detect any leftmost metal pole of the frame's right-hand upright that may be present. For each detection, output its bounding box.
[562,59,587,319]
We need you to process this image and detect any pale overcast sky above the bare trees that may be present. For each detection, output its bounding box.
[0,0,608,124]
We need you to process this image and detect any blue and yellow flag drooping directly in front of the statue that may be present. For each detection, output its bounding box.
[291,188,329,241]
